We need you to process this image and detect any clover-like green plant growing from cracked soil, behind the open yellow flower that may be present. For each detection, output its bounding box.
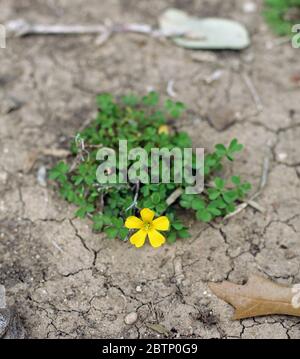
[49,92,251,243]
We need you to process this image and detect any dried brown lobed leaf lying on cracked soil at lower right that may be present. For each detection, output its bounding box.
[209,275,300,319]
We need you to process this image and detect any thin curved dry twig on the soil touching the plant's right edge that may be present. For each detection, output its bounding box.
[224,144,271,220]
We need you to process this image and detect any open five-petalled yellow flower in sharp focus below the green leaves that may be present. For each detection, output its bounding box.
[125,208,170,248]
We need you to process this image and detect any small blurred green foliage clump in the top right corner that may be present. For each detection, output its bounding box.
[263,0,300,36]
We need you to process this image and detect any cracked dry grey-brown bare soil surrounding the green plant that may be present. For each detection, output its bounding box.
[0,0,300,338]
